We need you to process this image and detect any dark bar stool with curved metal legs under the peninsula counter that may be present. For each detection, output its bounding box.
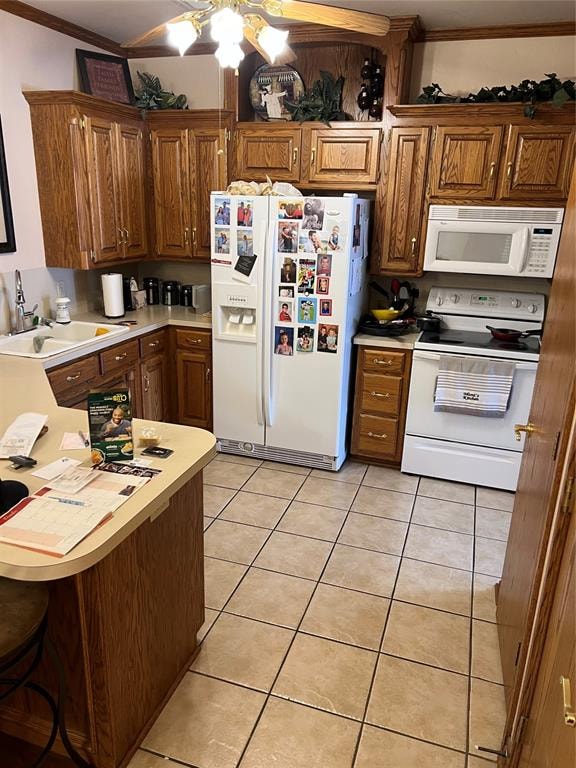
[0,577,90,768]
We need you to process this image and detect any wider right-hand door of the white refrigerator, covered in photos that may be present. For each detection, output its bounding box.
[264,197,367,464]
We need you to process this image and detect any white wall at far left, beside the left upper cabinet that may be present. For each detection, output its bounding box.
[0,11,108,331]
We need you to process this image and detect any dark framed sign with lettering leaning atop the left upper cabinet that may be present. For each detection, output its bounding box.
[76,48,134,104]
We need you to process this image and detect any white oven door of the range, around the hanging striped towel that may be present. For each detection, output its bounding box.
[406,350,538,452]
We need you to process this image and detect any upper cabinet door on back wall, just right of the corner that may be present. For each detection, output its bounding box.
[152,128,193,259]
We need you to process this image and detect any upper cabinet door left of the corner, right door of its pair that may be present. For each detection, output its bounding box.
[118,125,148,259]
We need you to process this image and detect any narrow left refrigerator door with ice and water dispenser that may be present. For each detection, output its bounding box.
[211,193,268,444]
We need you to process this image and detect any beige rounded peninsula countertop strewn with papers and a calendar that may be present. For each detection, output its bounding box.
[0,356,216,581]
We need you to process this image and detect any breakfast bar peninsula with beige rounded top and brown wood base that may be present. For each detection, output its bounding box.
[0,356,215,768]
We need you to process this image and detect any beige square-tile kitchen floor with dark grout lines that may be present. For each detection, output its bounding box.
[129,455,514,768]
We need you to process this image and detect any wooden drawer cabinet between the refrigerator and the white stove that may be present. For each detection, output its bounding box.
[350,346,412,466]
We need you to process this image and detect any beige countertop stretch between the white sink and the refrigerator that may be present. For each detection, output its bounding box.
[38,304,212,370]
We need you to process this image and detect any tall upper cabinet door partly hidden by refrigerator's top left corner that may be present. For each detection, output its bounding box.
[190,128,228,257]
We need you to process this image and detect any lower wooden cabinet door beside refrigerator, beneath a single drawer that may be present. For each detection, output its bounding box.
[176,350,212,429]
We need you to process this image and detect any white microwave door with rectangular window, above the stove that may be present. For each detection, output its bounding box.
[424,220,530,275]
